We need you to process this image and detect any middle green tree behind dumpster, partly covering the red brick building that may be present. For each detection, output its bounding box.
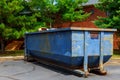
[29,0,89,27]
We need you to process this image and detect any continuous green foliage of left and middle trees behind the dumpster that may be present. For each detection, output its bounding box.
[0,0,89,39]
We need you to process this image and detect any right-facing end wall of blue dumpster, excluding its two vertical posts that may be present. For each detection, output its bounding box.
[71,31,113,67]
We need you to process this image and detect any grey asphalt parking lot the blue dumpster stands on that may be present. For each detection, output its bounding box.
[0,60,120,80]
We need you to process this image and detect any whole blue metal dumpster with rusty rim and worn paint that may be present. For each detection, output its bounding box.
[25,27,116,75]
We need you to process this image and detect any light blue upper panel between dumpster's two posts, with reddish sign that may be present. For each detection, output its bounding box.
[87,31,100,56]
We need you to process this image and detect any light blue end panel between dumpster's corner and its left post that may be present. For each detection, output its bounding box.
[72,31,84,57]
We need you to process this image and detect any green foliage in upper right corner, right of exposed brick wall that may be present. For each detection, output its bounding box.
[95,0,120,30]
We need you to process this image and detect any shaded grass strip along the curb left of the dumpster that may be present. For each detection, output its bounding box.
[0,50,24,57]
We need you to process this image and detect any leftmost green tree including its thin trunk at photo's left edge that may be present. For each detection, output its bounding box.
[0,0,41,52]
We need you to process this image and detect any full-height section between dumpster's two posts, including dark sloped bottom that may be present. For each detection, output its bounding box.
[84,31,101,67]
